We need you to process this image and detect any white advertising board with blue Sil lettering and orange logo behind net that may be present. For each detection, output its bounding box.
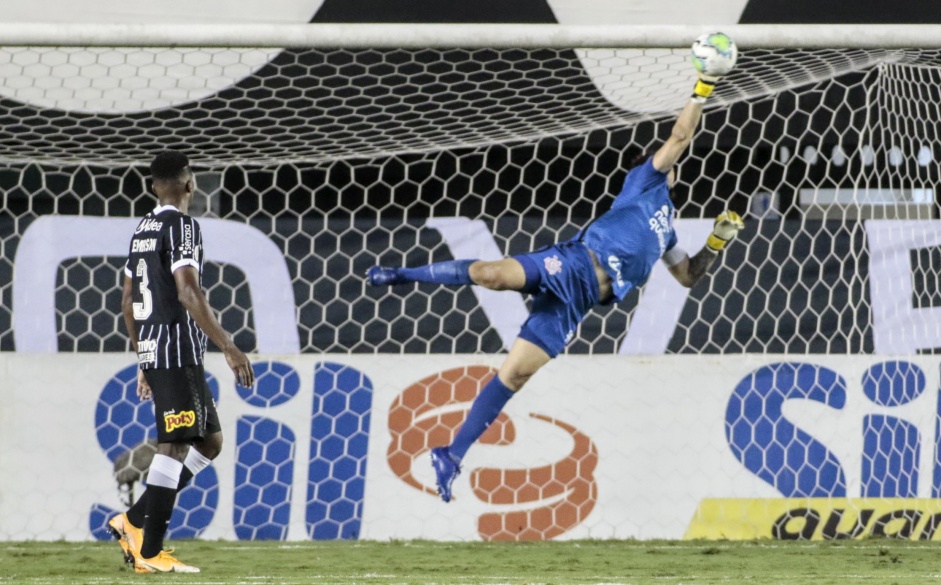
[0,353,941,540]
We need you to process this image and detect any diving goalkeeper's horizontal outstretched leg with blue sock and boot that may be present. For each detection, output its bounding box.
[367,258,527,290]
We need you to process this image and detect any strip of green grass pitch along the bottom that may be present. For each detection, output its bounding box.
[0,540,941,585]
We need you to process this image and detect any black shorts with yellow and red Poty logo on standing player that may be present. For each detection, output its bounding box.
[144,366,222,443]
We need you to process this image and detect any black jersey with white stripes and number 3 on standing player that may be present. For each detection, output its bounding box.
[124,205,206,370]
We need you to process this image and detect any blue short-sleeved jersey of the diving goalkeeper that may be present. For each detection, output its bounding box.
[576,157,676,300]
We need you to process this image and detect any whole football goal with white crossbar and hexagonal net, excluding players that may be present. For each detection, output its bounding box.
[0,23,941,540]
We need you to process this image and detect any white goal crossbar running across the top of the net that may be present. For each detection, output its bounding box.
[0,23,941,49]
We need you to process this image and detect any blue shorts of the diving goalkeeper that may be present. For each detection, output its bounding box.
[513,242,601,358]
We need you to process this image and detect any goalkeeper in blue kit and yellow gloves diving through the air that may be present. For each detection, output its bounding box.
[367,37,744,502]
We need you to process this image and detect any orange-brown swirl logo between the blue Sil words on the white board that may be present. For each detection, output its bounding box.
[387,368,598,541]
